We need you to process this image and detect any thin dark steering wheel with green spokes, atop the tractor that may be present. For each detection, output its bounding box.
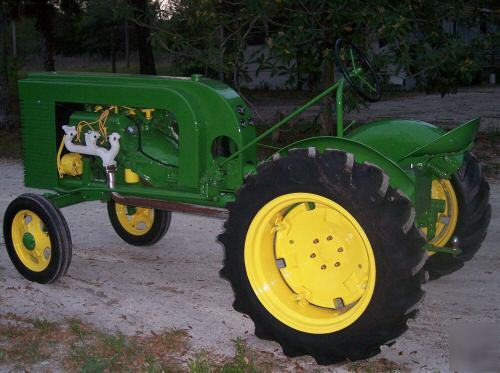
[335,39,382,102]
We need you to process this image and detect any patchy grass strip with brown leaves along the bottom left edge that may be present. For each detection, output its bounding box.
[0,314,280,373]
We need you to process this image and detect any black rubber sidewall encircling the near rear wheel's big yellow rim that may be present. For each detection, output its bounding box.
[225,152,424,360]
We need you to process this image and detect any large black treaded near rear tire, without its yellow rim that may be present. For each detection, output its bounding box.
[218,148,427,364]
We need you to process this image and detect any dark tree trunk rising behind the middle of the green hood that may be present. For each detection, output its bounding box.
[129,0,156,75]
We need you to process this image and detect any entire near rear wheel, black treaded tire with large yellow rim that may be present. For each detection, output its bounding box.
[219,148,427,364]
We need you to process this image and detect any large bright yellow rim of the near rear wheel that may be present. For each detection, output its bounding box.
[245,193,376,334]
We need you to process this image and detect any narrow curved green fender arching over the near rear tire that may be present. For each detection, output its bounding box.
[278,136,415,200]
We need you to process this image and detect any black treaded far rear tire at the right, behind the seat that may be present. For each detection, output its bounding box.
[426,152,491,280]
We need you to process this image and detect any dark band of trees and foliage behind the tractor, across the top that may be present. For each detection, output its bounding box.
[0,0,500,134]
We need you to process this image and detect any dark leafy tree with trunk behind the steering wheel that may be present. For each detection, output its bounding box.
[263,0,491,134]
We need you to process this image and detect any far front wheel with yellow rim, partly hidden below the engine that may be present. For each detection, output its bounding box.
[108,201,172,246]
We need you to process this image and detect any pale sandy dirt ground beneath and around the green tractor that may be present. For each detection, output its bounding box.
[0,156,500,371]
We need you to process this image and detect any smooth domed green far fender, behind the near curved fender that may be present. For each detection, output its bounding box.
[346,119,445,163]
